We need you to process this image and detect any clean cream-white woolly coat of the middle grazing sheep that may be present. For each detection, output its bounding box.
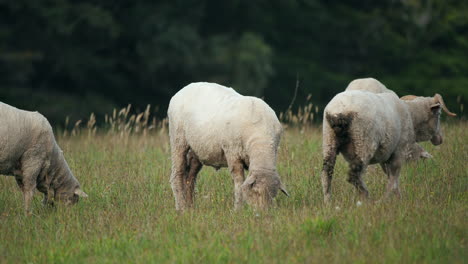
[168,83,282,170]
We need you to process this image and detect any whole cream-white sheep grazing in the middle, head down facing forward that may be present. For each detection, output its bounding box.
[168,83,287,210]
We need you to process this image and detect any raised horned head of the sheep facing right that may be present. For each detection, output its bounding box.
[400,94,456,146]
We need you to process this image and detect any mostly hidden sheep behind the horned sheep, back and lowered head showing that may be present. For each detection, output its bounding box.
[345,78,432,161]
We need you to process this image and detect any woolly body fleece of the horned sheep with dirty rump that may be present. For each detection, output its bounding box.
[323,90,415,164]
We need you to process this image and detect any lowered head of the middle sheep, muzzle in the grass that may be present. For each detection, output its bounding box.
[241,170,289,209]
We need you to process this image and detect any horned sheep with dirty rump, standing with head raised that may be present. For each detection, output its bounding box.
[321,83,455,203]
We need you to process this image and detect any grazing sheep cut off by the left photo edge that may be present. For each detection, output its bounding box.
[0,102,87,214]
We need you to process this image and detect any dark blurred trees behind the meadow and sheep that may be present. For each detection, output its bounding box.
[0,0,468,126]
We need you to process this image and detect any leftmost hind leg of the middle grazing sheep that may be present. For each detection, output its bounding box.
[170,142,189,211]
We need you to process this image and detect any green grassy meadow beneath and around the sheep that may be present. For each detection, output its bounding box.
[0,122,468,263]
